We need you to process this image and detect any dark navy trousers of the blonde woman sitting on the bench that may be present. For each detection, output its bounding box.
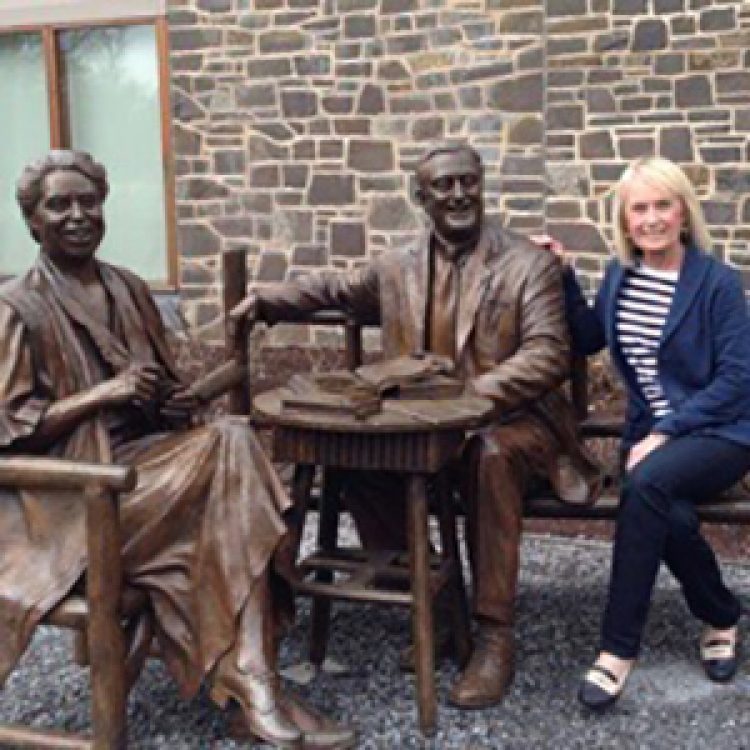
[602,435,750,659]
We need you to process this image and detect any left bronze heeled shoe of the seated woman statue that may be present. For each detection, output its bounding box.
[211,670,303,750]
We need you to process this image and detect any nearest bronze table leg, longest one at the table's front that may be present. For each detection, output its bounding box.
[407,475,437,734]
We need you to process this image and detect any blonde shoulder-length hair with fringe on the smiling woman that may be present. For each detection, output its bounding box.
[612,156,711,266]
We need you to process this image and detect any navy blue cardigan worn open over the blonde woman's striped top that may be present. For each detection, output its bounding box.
[564,248,750,447]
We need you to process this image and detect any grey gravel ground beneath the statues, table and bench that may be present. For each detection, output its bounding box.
[0,524,750,750]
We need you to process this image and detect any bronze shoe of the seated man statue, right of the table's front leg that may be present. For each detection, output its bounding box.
[448,624,514,709]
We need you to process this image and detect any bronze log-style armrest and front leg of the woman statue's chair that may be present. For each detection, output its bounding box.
[0,456,136,750]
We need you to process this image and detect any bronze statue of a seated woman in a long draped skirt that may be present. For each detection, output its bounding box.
[0,151,354,747]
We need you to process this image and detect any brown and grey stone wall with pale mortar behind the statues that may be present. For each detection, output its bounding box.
[169,0,750,334]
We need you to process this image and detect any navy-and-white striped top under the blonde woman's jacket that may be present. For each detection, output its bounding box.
[615,266,679,417]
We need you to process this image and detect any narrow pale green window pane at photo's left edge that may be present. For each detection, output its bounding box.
[0,33,49,275]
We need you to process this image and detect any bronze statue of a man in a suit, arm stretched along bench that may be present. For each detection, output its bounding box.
[233,144,594,708]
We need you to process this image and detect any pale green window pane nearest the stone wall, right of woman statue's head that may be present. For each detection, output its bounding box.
[60,25,167,281]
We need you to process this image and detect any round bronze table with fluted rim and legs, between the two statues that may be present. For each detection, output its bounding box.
[253,388,493,734]
